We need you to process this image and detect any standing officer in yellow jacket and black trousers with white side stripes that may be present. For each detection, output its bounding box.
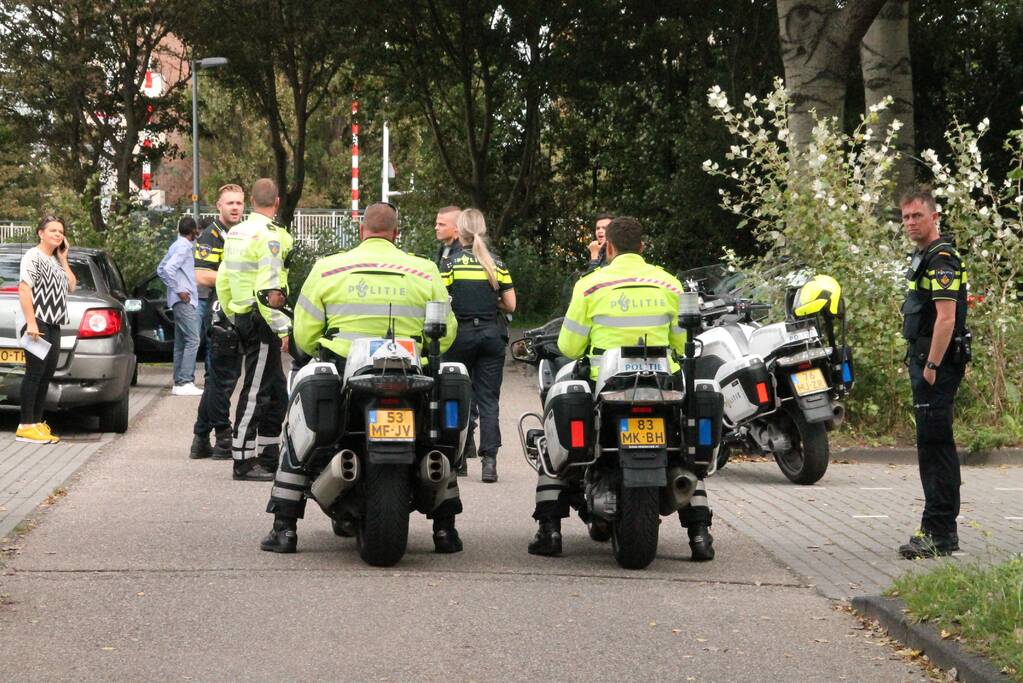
[217,178,294,482]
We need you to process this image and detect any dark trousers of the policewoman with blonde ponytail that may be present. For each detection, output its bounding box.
[443,318,508,456]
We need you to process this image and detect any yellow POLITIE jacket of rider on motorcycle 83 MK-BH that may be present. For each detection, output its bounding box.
[558,254,685,377]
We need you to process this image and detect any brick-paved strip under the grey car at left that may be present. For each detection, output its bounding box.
[0,367,171,541]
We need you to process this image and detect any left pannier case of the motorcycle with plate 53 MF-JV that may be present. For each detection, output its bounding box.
[284,362,345,463]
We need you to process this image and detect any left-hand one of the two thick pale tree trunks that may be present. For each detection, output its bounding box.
[777,0,887,147]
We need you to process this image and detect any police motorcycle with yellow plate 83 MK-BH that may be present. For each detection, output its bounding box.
[512,295,722,570]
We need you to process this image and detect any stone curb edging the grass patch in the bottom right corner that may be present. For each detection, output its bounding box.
[851,595,1010,683]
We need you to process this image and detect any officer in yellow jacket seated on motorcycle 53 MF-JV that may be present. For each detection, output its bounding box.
[261,203,462,553]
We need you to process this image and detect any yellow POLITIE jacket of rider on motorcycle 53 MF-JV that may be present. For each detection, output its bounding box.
[295,237,458,358]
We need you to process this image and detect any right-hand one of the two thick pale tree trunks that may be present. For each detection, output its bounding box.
[859,0,917,194]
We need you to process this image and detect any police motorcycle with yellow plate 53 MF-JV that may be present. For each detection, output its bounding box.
[283,302,472,566]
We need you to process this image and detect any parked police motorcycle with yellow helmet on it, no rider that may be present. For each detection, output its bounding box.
[680,269,853,485]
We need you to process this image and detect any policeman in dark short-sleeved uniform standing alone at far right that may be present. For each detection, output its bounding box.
[899,189,970,559]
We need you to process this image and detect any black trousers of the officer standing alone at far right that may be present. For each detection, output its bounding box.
[909,355,966,538]
